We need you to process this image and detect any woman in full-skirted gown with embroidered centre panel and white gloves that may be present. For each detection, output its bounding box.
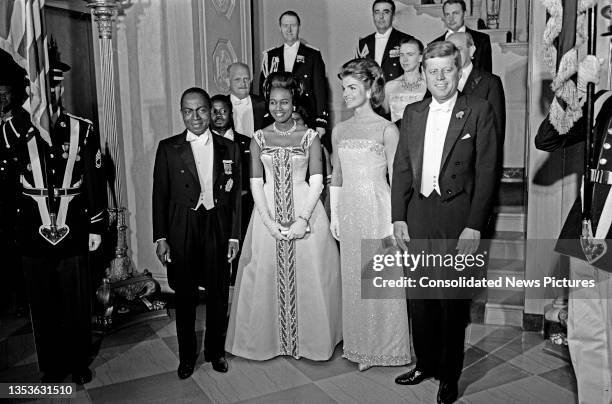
[225,72,342,360]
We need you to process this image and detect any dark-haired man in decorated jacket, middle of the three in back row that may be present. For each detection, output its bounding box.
[356,0,410,81]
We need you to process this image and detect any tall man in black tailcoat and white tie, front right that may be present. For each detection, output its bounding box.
[391,41,497,403]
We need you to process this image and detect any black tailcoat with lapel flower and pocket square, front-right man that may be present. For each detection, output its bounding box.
[391,93,497,232]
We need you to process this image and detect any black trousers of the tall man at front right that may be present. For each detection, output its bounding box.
[408,191,470,383]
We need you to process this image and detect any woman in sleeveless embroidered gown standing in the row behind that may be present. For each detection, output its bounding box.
[383,37,427,122]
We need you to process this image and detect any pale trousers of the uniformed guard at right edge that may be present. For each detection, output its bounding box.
[567,258,612,404]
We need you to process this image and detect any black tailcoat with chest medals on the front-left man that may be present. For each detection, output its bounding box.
[153,130,242,246]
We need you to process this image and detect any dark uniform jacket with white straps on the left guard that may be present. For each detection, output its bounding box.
[10,112,107,258]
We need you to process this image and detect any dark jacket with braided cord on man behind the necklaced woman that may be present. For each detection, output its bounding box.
[259,42,328,128]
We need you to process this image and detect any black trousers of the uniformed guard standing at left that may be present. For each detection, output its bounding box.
[22,255,91,375]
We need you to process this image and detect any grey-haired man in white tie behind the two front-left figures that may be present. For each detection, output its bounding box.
[227,62,272,137]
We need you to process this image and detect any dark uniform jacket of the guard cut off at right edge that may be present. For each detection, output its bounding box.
[535,91,612,271]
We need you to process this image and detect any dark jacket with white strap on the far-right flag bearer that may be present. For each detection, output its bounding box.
[535,91,612,271]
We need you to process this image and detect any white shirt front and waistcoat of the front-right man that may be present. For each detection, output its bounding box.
[421,93,457,197]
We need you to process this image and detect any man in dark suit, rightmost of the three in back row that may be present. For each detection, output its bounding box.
[432,0,492,73]
